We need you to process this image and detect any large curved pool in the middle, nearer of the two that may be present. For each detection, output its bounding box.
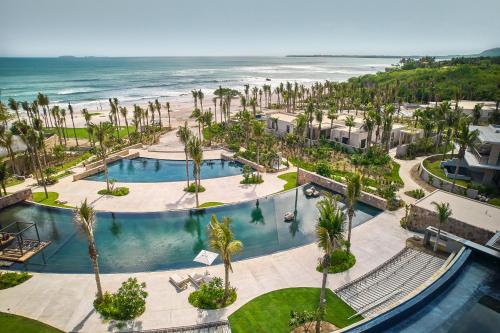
[0,186,380,273]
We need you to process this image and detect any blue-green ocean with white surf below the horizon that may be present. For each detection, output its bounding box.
[0,57,398,108]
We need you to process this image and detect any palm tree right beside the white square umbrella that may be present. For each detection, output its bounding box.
[208,214,243,306]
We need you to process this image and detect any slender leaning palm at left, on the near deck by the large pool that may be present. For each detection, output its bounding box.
[74,199,103,303]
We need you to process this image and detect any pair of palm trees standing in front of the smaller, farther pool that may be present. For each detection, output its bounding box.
[177,121,203,207]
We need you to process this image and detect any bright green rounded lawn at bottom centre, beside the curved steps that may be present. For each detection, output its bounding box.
[229,288,362,333]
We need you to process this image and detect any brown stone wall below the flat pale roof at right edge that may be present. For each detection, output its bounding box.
[408,205,494,245]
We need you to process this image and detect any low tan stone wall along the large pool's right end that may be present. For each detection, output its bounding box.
[299,169,387,210]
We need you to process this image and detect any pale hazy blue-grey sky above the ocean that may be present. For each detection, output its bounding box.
[0,0,500,57]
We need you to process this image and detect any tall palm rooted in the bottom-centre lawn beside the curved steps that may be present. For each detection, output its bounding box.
[316,192,345,333]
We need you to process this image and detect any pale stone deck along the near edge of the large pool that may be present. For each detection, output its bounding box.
[0,210,411,332]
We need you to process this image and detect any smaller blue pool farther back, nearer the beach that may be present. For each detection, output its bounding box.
[85,157,243,183]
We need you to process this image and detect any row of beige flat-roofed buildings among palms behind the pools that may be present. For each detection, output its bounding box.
[267,112,408,149]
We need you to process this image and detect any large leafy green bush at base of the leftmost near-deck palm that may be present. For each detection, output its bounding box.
[94,278,148,320]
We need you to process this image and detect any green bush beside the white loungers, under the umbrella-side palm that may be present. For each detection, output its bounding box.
[188,277,236,309]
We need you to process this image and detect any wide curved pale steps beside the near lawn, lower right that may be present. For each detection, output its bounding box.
[335,248,445,318]
